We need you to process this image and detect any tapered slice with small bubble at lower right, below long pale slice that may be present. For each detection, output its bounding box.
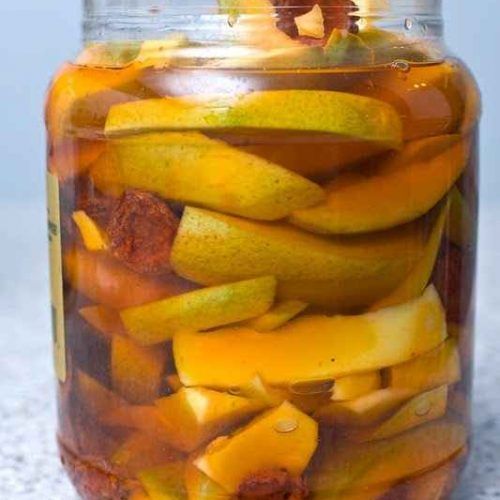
[349,385,448,442]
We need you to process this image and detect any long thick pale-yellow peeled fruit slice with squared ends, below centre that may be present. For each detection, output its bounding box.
[174,286,446,388]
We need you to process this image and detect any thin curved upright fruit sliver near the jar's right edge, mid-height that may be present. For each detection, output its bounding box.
[371,202,450,311]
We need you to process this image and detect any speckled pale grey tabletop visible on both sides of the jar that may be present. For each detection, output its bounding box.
[0,202,500,500]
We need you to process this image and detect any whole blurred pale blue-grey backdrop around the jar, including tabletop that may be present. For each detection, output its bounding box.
[0,0,500,500]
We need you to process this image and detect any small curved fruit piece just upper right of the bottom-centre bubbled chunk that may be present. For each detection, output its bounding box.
[314,389,411,426]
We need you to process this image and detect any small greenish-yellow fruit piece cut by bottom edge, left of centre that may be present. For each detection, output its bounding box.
[137,461,186,500]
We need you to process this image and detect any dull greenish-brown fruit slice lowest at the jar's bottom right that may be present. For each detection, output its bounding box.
[311,420,467,498]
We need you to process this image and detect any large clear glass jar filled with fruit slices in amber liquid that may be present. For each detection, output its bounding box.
[47,0,480,500]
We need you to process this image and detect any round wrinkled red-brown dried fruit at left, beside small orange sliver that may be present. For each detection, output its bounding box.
[107,191,179,275]
